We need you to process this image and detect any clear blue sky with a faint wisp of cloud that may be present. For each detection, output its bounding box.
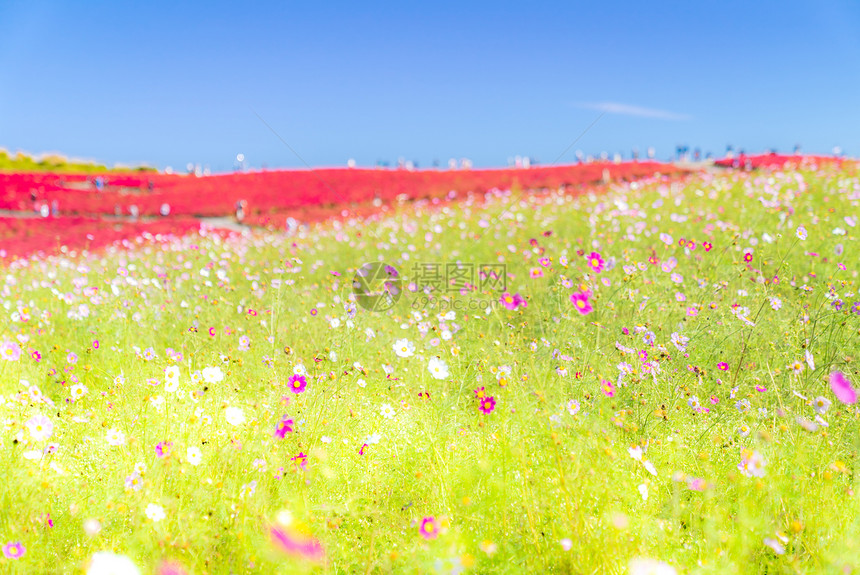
[0,0,860,171]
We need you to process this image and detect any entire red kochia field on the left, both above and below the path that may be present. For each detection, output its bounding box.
[0,162,680,258]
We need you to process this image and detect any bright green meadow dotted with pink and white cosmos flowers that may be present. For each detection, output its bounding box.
[0,163,860,574]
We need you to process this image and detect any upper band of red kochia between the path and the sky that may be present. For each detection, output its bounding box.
[0,162,678,216]
